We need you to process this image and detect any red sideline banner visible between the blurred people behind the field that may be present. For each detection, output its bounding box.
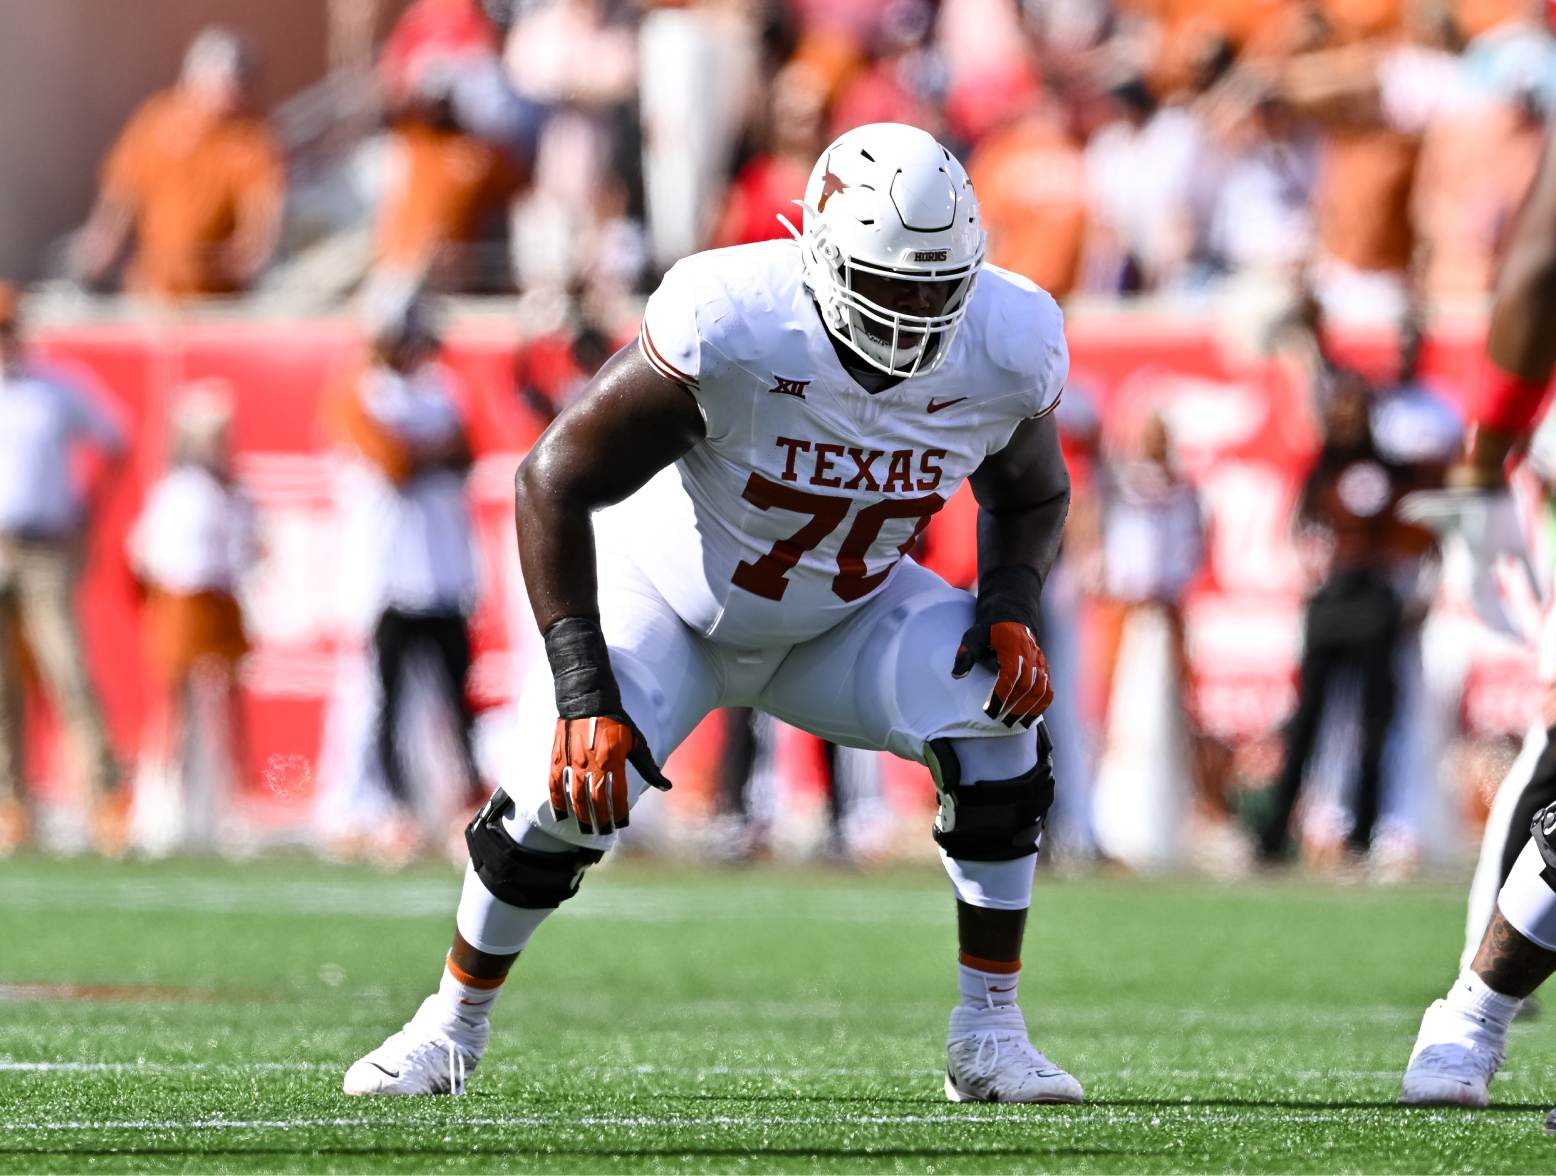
[24,313,1536,810]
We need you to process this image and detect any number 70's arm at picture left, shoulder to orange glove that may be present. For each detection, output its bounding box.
[513,344,703,832]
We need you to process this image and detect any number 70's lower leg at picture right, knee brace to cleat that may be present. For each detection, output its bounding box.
[927,726,1083,1103]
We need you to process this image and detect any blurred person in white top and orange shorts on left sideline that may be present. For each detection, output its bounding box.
[129,381,255,852]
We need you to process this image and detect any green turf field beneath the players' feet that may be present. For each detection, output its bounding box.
[0,860,1556,1173]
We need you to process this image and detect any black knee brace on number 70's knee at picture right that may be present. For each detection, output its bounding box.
[926,723,1053,862]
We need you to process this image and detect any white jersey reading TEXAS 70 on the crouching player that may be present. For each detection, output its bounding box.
[598,241,1069,649]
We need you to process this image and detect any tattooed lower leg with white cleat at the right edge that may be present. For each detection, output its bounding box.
[1400,806,1556,1106]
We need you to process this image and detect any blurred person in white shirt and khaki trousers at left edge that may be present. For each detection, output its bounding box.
[0,283,124,852]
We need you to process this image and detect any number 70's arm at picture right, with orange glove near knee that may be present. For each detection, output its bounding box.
[951,412,1071,726]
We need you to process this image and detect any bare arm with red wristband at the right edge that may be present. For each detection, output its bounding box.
[1450,134,1556,487]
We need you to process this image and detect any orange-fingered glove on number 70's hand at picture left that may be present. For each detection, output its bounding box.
[551,716,669,834]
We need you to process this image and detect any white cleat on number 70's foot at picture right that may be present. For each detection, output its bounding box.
[946,1005,1086,1103]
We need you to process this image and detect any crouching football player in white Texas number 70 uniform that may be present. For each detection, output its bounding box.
[345,123,1081,1103]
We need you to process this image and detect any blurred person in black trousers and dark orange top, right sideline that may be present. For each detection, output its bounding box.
[1259,372,1430,860]
